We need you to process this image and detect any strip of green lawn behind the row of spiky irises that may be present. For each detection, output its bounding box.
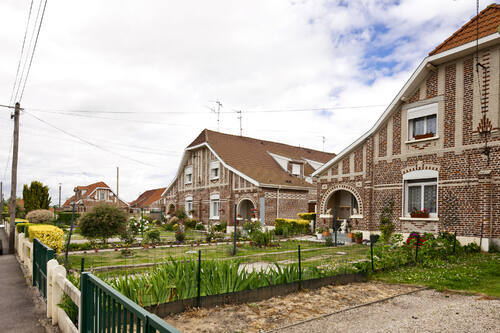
[68,241,367,269]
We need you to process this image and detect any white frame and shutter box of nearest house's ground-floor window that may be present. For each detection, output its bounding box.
[403,170,439,218]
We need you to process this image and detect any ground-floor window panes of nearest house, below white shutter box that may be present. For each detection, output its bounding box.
[405,178,437,217]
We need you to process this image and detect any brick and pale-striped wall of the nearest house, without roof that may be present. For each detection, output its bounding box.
[317,44,500,249]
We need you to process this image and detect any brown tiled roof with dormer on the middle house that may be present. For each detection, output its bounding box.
[188,129,335,187]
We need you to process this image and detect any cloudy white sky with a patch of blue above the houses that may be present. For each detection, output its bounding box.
[0,0,493,204]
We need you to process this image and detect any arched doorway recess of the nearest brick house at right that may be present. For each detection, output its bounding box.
[325,189,360,229]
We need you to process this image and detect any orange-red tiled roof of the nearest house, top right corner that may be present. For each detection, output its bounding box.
[429,4,500,55]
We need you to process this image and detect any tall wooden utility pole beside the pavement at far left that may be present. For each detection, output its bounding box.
[9,102,21,254]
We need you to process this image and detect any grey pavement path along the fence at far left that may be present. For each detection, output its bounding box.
[0,228,50,333]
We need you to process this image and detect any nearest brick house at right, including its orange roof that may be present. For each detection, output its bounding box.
[313,4,500,249]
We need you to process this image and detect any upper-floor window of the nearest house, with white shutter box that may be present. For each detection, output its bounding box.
[408,103,438,140]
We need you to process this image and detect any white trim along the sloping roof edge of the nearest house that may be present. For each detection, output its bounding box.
[312,32,500,177]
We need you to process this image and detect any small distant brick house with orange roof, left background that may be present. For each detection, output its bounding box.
[63,182,128,212]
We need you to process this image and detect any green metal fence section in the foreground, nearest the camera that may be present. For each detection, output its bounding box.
[80,273,179,333]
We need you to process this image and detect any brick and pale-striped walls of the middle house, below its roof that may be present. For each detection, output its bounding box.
[162,147,310,226]
